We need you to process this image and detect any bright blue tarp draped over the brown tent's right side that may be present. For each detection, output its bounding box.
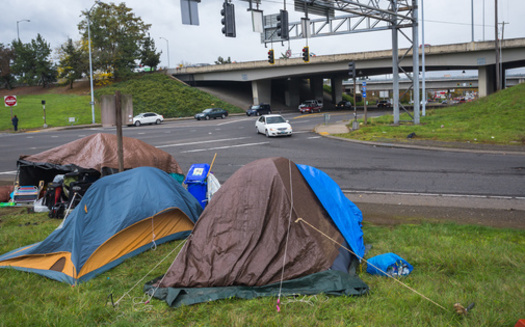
[297,165,365,260]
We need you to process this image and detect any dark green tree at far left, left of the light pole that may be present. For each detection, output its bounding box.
[12,34,58,87]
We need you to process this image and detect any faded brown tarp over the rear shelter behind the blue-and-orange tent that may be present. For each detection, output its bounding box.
[17,133,184,185]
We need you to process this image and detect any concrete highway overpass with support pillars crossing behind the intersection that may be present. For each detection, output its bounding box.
[168,38,525,107]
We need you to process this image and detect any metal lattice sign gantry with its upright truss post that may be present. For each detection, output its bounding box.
[256,0,420,124]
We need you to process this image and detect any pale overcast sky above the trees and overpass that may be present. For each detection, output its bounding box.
[0,0,525,72]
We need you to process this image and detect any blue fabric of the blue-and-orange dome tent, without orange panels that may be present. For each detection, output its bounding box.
[0,167,202,284]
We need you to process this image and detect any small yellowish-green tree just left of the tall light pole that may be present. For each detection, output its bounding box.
[58,38,89,88]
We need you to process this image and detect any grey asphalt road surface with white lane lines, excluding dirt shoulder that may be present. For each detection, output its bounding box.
[0,112,525,197]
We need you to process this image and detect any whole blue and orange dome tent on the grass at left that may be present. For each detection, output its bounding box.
[0,167,202,284]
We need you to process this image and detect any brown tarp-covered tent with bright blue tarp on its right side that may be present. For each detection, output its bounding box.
[145,158,368,306]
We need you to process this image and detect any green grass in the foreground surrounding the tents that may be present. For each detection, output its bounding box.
[0,208,525,327]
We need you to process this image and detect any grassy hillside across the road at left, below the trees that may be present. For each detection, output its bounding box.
[0,74,243,131]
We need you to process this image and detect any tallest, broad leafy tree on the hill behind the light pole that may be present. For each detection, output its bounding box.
[78,3,151,79]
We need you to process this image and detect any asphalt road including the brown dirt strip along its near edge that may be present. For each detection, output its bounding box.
[0,112,525,228]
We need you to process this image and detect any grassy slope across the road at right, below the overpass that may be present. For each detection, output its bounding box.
[338,83,525,145]
